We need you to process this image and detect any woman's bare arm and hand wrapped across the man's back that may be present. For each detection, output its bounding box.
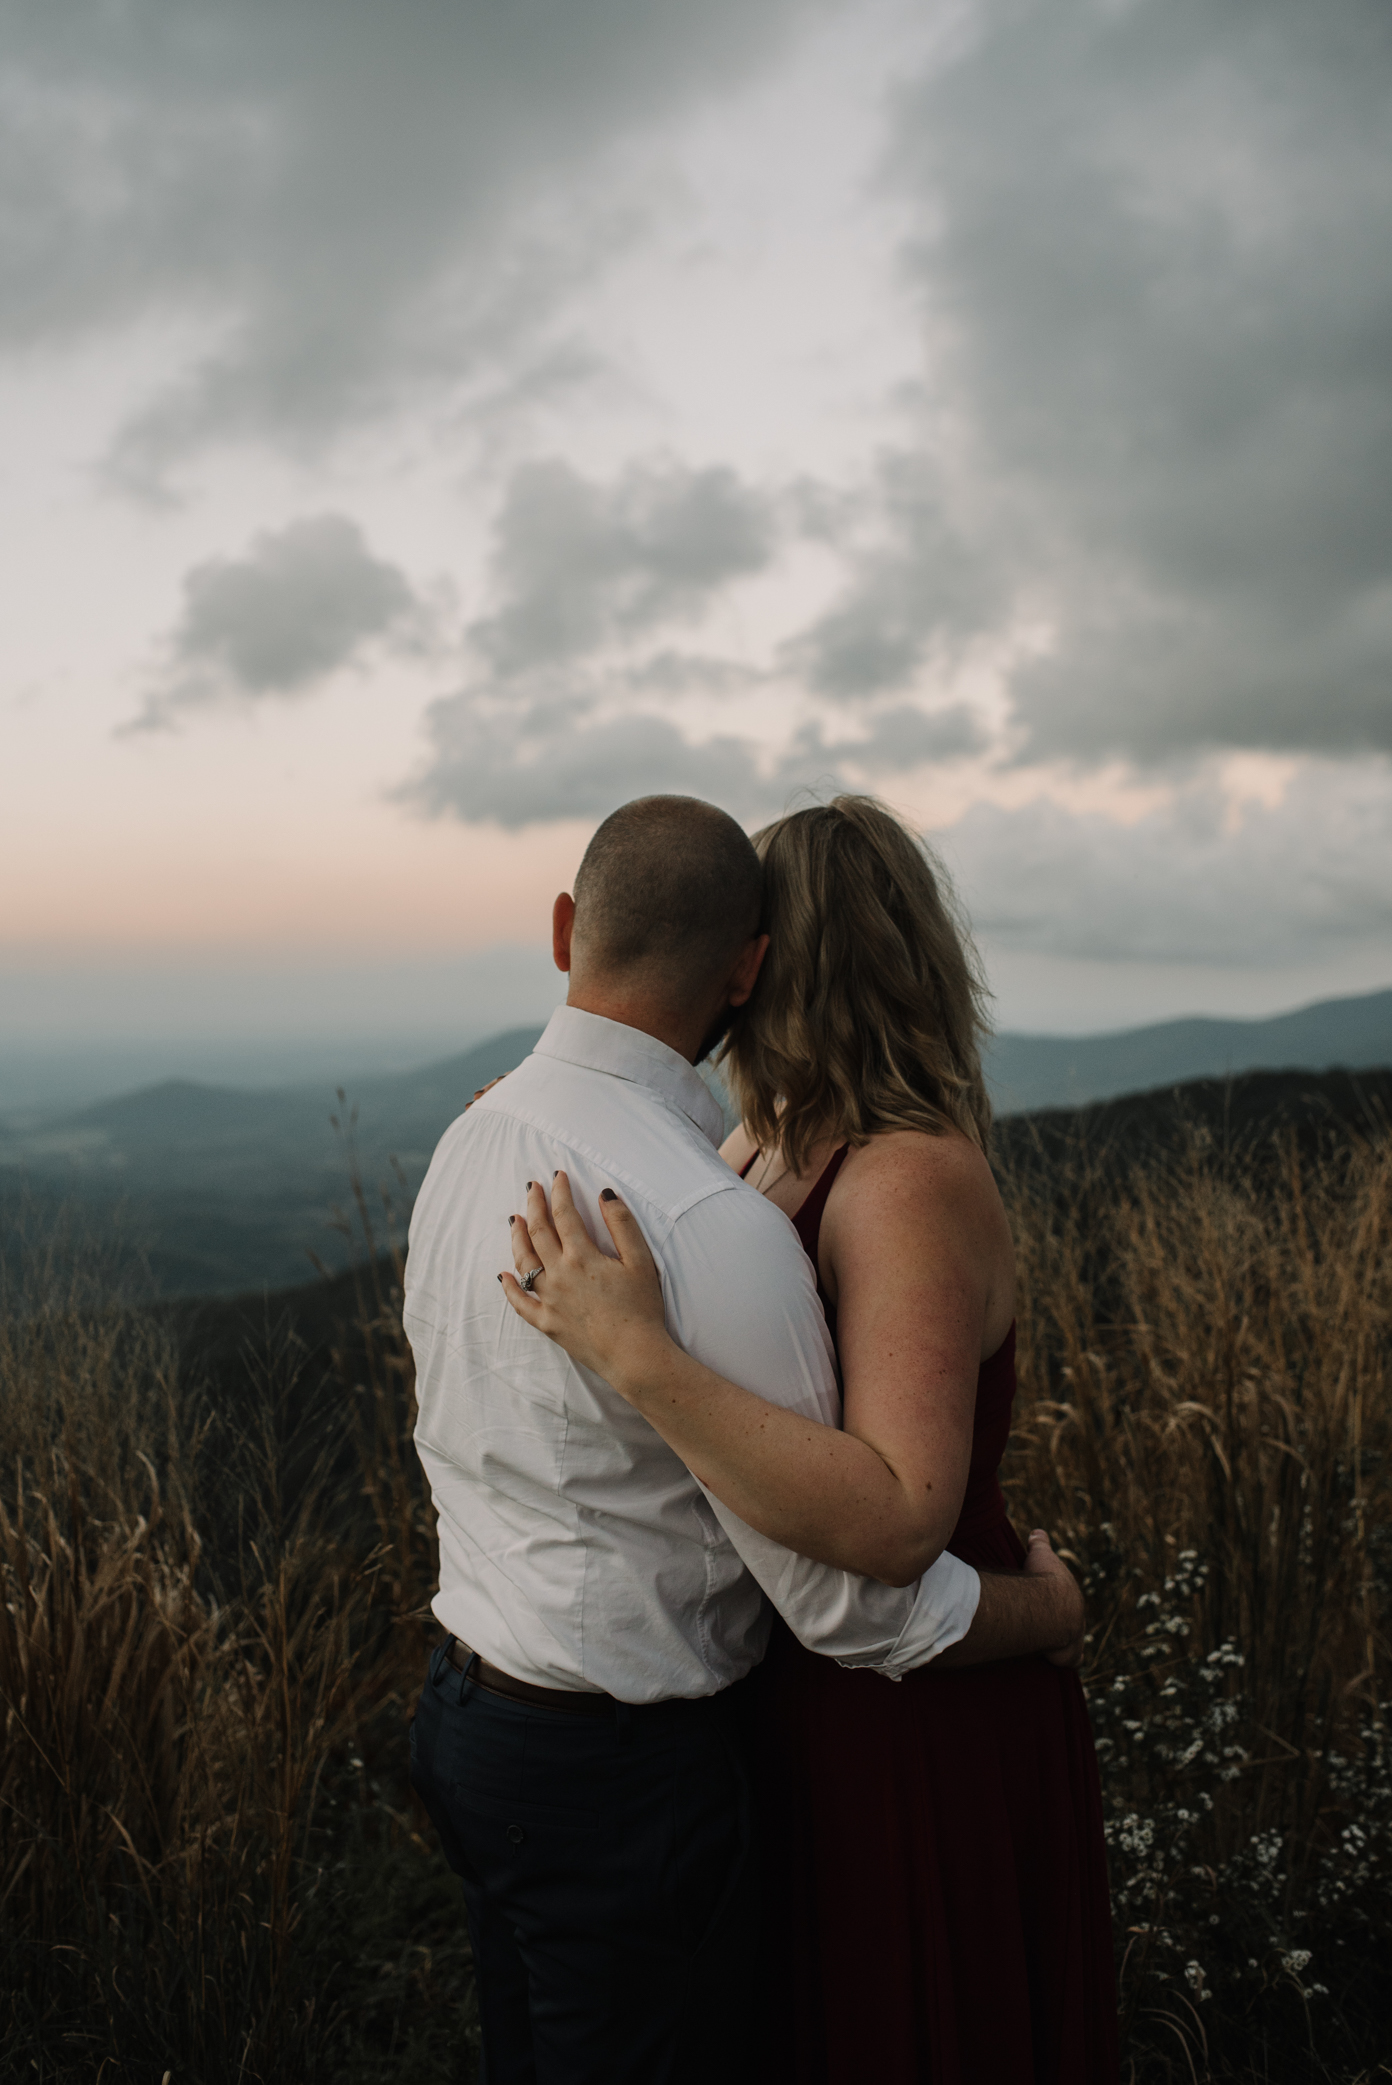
[504,1138,996,1585]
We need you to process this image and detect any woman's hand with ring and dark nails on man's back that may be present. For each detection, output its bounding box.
[498,1172,671,1403]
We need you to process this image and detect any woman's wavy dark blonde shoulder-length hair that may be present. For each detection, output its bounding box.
[721,796,990,1174]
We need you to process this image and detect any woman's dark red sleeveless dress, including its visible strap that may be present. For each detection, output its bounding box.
[759,1151,1117,2085]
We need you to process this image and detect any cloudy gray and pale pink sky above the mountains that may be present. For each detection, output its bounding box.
[0,0,1392,1101]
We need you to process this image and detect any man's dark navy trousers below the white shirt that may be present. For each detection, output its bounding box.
[411,1649,759,2085]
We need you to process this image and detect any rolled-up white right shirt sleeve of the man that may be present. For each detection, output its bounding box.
[661,1188,981,1678]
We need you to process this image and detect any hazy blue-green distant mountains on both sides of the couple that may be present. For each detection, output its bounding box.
[0,990,1392,1295]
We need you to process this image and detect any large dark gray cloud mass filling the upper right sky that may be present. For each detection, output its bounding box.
[862,0,1392,761]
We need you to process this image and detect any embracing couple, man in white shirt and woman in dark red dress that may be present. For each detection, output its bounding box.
[406,796,1117,2085]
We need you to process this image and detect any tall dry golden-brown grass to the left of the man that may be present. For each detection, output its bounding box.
[0,1192,469,2085]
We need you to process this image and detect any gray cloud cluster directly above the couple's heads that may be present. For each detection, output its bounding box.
[400,459,986,828]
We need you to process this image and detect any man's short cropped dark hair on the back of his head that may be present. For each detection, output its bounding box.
[575,796,763,992]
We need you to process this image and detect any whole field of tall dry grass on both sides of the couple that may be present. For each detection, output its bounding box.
[0,1100,1392,2085]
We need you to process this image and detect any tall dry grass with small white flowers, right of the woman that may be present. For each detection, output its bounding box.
[1004,1136,1392,2079]
